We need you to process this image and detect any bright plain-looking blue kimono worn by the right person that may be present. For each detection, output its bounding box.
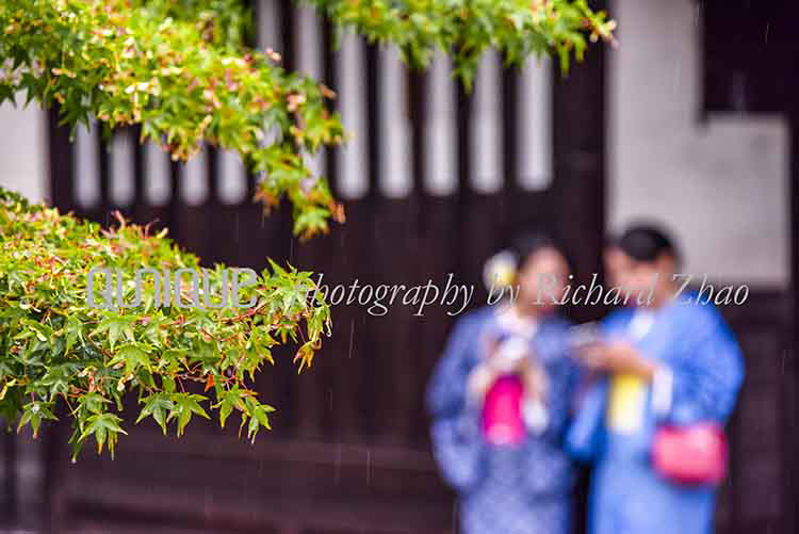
[567,294,744,534]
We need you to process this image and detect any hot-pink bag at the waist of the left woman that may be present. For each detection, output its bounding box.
[482,374,526,445]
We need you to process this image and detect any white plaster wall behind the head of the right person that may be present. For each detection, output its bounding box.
[607,0,790,287]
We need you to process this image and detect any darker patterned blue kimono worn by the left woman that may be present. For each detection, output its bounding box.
[427,308,578,534]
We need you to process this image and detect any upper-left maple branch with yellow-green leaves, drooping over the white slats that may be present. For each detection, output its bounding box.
[0,0,344,236]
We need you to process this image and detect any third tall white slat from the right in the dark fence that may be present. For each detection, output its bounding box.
[424,53,458,195]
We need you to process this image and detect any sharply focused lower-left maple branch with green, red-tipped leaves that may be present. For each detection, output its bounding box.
[0,189,330,455]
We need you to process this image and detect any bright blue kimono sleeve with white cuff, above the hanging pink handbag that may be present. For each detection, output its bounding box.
[652,306,744,425]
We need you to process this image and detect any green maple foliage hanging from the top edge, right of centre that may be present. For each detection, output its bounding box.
[310,0,616,89]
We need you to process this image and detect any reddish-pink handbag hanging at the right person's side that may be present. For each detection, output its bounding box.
[652,423,728,485]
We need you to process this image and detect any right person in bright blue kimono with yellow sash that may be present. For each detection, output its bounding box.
[567,225,744,534]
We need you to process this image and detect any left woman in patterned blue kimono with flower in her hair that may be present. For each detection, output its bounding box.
[426,235,579,534]
